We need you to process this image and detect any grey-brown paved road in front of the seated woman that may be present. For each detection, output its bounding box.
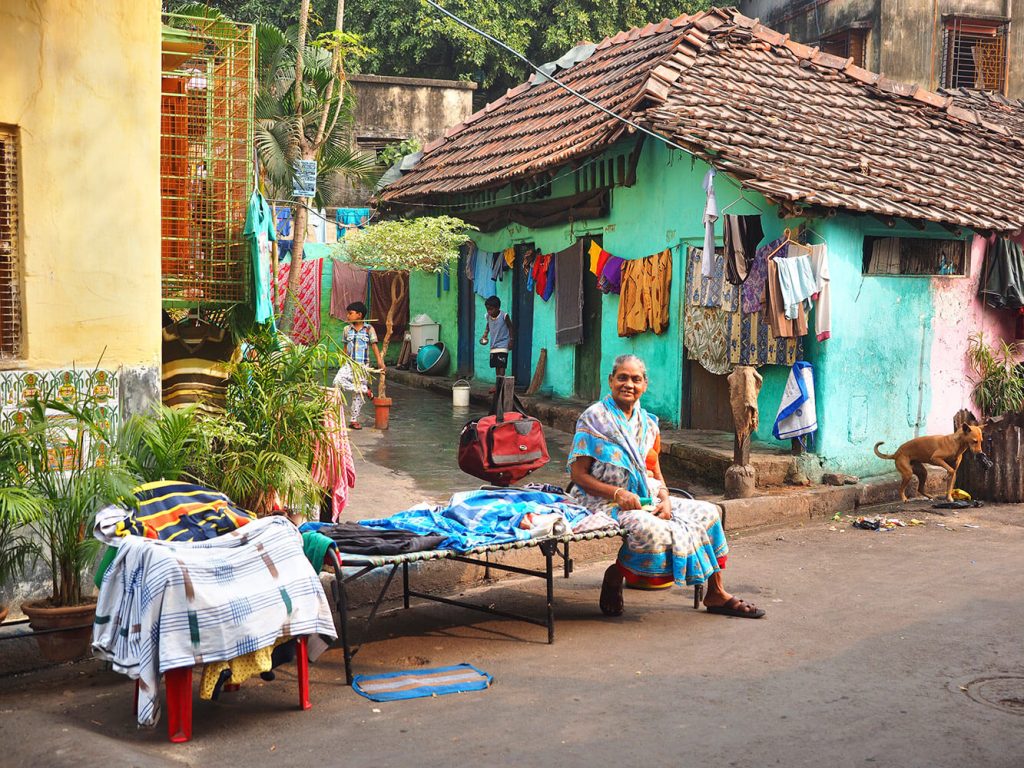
[0,507,1024,768]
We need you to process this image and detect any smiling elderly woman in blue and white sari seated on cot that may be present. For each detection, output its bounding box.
[568,354,765,618]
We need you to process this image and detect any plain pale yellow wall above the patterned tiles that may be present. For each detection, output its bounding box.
[0,0,161,369]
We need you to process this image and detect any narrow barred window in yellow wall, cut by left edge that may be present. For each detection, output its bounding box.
[0,126,22,360]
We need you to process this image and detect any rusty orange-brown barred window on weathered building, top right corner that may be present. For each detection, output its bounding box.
[942,16,1010,93]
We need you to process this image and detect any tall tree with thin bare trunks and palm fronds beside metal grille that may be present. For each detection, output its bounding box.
[255,0,384,331]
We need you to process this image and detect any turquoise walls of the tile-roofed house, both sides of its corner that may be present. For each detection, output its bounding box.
[401,139,966,474]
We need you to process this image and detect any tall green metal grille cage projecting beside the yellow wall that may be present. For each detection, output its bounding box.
[160,13,256,307]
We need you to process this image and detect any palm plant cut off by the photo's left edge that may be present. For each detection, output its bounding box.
[0,430,42,622]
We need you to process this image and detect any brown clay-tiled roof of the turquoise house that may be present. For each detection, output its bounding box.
[384,9,1024,231]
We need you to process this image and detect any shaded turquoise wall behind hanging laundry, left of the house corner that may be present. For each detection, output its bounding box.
[411,139,788,439]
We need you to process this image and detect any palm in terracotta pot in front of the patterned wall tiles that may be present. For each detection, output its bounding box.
[22,400,134,662]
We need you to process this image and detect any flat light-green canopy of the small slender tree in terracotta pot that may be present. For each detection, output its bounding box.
[335,216,476,272]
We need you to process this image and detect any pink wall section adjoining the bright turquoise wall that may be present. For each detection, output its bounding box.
[927,237,1016,434]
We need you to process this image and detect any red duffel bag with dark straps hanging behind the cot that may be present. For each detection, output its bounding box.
[459,381,550,485]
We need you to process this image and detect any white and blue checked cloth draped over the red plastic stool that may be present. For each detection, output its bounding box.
[92,517,337,725]
